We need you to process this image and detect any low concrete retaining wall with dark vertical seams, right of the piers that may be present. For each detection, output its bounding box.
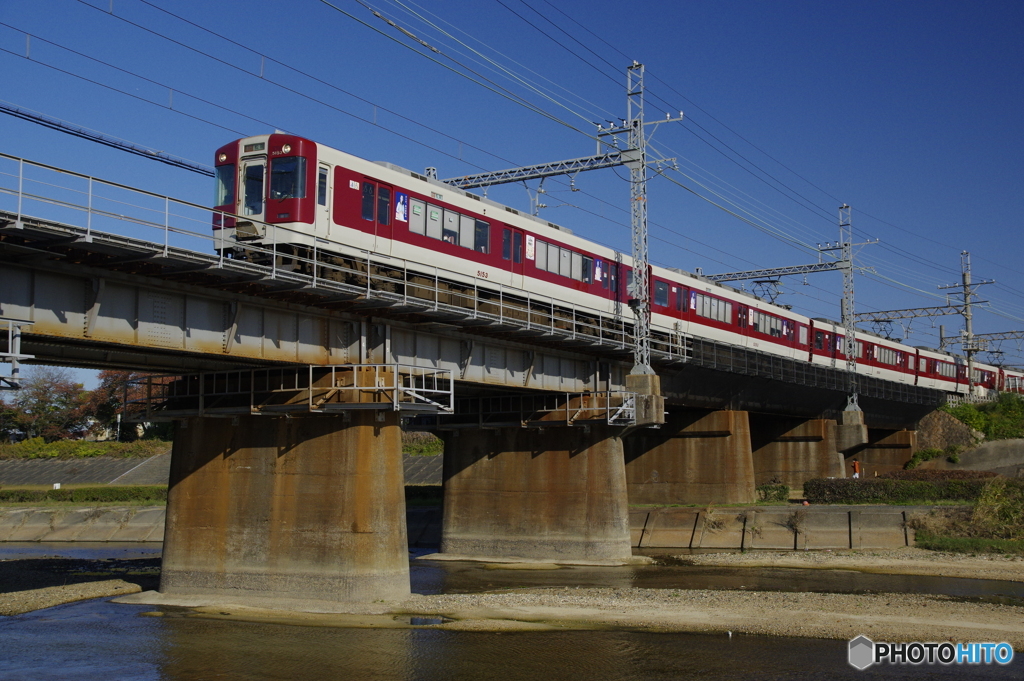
[630,506,917,550]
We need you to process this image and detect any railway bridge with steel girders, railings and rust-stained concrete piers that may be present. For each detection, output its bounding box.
[0,157,943,601]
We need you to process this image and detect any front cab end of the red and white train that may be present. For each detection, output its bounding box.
[213,134,317,268]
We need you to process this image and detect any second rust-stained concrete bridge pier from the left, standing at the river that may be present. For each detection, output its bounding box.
[440,425,631,561]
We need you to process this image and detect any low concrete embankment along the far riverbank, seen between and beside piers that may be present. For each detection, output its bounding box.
[0,506,929,549]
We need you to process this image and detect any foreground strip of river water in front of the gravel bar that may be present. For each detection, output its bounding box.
[0,600,1024,681]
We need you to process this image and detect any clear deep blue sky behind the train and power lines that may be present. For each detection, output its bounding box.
[0,0,1024,378]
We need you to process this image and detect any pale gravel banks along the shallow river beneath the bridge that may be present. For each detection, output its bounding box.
[8,549,1024,650]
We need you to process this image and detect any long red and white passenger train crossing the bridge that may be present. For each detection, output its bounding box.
[214,134,1024,393]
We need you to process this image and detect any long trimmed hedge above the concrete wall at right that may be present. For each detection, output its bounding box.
[804,477,999,504]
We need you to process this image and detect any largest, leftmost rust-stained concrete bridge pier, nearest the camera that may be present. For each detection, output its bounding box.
[160,411,410,603]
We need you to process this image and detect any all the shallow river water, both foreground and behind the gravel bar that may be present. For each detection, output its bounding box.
[0,545,1024,681]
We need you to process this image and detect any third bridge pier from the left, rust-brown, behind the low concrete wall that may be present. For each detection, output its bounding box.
[625,410,755,504]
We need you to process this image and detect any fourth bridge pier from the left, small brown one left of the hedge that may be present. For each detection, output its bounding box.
[750,414,844,491]
